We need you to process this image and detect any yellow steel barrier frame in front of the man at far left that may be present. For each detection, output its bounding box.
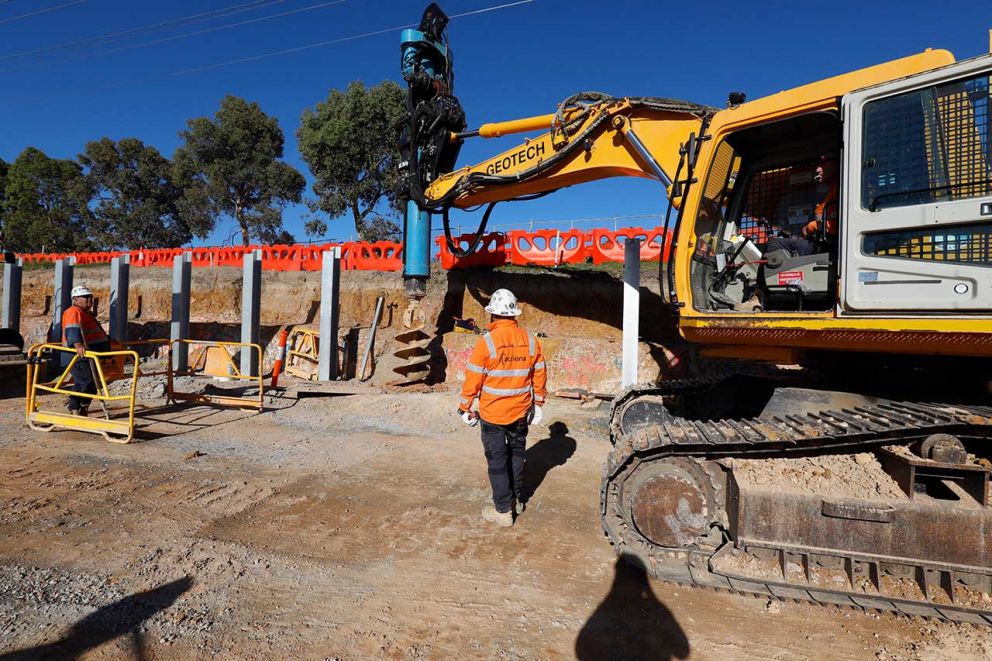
[25,344,140,443]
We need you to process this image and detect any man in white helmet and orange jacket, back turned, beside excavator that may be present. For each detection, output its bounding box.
[458,289,548,526]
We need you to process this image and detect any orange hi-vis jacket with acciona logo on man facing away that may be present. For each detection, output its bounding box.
[458,319,548,425]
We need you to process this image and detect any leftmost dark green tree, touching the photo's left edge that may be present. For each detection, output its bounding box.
[2,147,94,252]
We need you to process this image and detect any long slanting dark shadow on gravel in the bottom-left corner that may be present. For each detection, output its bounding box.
[0,576,193,661]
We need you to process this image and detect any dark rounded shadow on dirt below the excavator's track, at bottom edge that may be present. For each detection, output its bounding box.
[575,556,689,661]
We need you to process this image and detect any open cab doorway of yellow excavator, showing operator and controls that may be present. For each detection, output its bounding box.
[690,112,841,312]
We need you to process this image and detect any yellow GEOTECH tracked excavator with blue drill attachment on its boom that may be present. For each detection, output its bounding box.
[400,5,992,625]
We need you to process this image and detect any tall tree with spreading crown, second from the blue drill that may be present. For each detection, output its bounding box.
[173,95,306,245]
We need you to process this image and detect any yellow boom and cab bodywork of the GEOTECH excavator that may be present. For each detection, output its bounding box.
[426,50,992,363]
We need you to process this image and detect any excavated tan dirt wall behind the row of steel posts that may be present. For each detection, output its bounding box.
[1,266,680,392]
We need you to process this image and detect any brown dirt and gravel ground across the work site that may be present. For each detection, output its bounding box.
[0,374,992,659]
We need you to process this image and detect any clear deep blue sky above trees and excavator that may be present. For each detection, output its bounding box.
[0,0,992,245]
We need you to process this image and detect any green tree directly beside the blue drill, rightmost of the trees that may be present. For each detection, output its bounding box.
[296,80,405,241]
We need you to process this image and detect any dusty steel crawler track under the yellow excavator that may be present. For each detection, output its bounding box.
[600,390,992,626]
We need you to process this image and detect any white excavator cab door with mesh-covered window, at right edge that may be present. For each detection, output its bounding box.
[840,56,992,314]
